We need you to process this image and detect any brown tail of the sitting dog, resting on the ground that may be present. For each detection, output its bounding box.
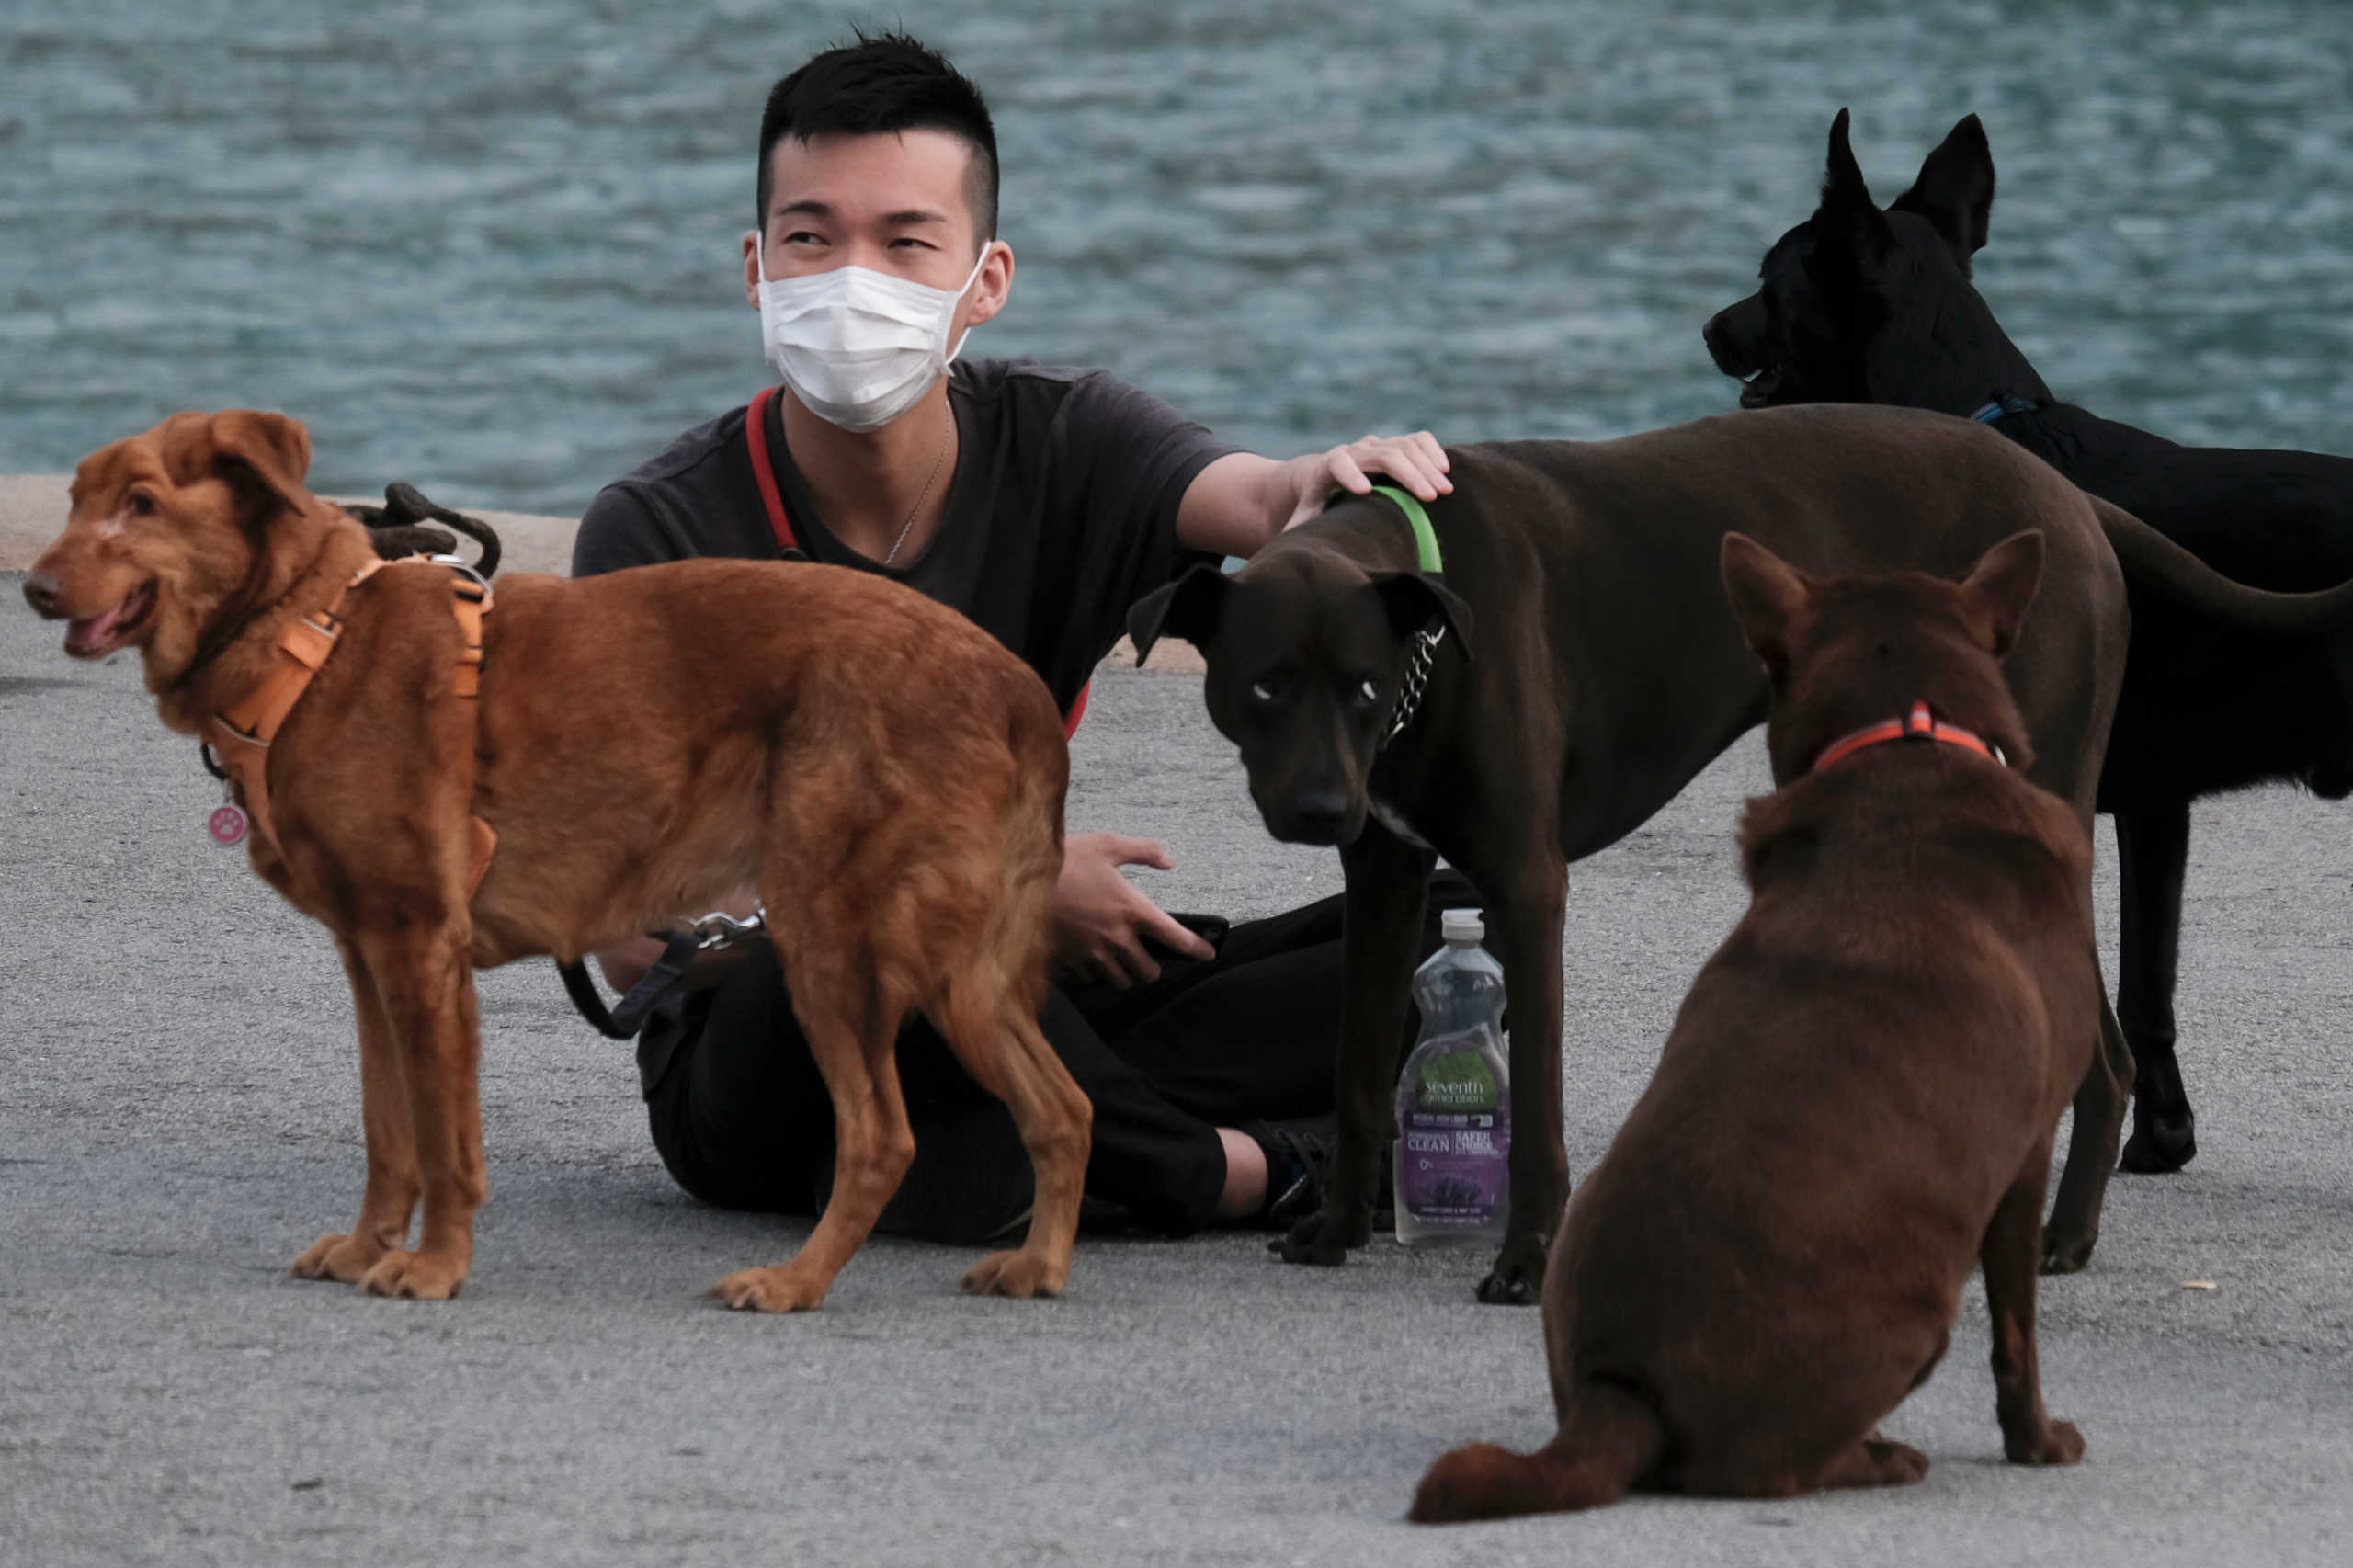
[1404,1380,1665,1523]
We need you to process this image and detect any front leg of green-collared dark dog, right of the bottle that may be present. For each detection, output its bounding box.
[1466,846,1570,1307]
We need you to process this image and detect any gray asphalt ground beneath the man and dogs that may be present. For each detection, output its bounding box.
[0,577,2353,1568]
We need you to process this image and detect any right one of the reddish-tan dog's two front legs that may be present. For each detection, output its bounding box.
[356,923,489,1302]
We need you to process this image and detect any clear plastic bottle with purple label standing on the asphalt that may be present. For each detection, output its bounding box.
[1395,909,1511,1245]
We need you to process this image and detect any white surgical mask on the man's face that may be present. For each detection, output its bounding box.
[751,233,988,431]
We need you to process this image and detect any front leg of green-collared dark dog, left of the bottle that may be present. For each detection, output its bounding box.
[1282,819,1438,1267]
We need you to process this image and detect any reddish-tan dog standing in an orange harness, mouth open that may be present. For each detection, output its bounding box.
[26,410,1089,1312]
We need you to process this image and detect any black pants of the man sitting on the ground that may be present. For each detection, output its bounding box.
[638,871,1478,1244]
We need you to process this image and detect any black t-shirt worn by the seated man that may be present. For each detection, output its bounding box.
[572,360,1238,711]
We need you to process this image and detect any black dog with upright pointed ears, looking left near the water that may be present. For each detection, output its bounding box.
[1706,108,2353,1170]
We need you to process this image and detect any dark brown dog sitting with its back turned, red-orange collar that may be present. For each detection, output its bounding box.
[1412,532,2099,1523]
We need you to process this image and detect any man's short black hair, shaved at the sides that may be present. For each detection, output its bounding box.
[753,33,997,244]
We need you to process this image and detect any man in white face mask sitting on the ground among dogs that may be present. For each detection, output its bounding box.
[572,35,1475,1241]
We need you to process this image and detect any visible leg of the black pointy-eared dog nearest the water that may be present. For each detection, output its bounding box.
[2115,801,2198,1173]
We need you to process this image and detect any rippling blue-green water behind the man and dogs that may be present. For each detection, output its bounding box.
[0,0,2353,511]
